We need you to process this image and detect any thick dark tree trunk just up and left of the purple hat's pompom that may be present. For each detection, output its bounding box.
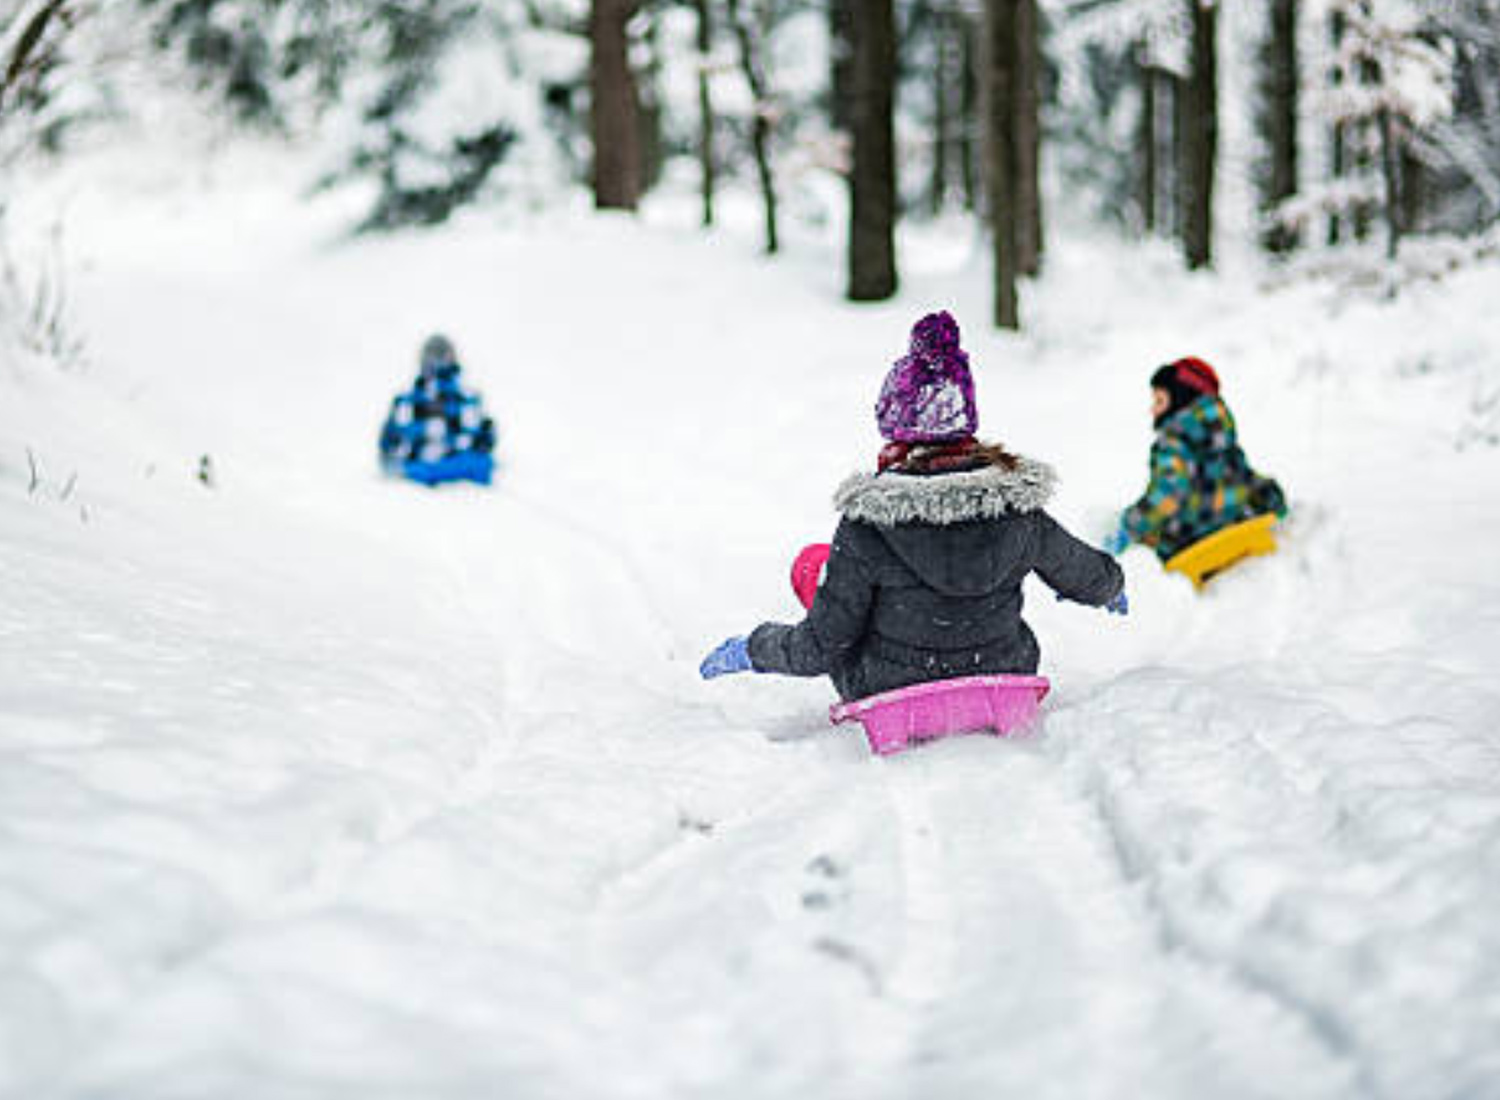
[849,0,896,302]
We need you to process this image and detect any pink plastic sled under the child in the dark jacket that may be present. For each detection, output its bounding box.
[828,675,1052,756]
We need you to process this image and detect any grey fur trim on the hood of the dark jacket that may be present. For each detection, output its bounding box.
[834,456,1058,528]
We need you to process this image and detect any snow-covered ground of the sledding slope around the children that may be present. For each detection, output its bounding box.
[0,141,1500,1100]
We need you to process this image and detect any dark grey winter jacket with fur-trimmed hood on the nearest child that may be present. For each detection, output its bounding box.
[750,458,1125,699]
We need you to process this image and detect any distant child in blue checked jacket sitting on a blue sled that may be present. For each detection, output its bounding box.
[380,336,495,485]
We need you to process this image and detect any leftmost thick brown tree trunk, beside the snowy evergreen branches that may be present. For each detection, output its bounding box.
[588,0,642,210]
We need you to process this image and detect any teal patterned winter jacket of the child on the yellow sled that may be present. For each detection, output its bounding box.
[1121,396,1287,561]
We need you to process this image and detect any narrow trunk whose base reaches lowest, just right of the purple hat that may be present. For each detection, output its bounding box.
[984,0,1022,329]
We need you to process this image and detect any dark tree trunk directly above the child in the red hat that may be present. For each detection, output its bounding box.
[1181,0,1218,270]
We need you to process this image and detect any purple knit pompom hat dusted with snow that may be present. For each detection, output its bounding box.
[875,311,980,443]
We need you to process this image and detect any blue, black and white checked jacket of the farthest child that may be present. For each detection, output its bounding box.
[380,363,495,473]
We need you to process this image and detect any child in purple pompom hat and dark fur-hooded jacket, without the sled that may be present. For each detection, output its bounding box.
[699,312,1127,699]
